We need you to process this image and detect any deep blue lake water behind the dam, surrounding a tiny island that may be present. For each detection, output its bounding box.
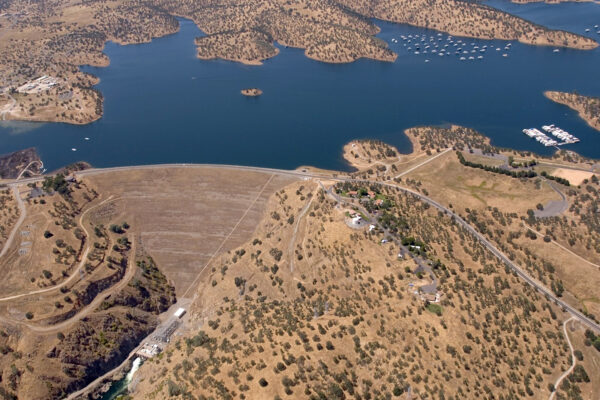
[0,0,600,170]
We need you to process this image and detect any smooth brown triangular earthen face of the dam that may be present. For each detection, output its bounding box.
[88,167,294,295]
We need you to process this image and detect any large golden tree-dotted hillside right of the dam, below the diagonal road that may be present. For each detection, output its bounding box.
[131,179,594,399]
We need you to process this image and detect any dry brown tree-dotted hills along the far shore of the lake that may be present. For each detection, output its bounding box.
[0,0,598,124]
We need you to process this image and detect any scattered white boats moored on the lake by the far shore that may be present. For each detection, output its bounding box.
[391,33,512,62]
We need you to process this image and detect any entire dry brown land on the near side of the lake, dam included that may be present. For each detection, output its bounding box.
[0,126,600,399]
